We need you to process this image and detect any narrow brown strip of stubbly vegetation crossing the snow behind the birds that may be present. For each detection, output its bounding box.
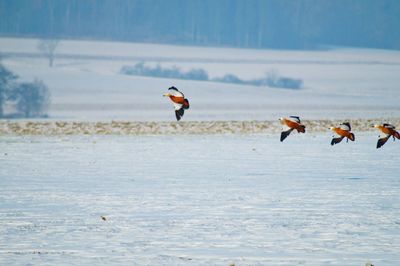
[0,118,400,136]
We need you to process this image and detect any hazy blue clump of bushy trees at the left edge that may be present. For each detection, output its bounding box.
[0,62,50,118]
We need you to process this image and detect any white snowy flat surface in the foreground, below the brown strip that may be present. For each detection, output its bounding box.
[0,133,400,266]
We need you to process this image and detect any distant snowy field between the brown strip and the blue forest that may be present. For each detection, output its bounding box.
[0,38,400,121]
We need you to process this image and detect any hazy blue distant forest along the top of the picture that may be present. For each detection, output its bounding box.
[0,0,400,49]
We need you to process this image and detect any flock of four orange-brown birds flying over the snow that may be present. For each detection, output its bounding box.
[164,87,400,149]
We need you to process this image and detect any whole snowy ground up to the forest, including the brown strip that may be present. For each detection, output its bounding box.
[0,38,400,266]
